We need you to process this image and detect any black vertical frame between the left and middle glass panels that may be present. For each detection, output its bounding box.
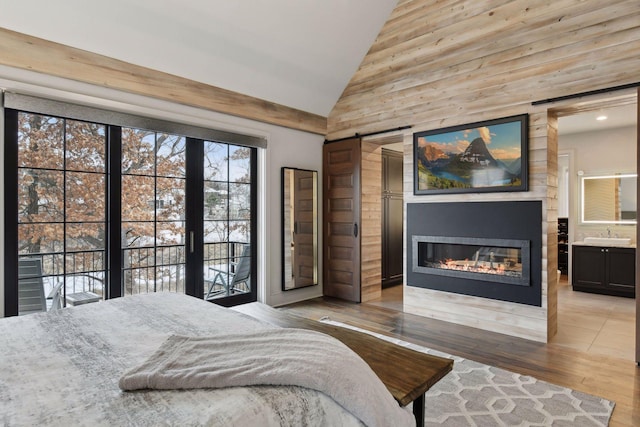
[105,126,123,299]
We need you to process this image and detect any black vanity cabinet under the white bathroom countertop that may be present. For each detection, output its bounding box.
[571,245,636,298]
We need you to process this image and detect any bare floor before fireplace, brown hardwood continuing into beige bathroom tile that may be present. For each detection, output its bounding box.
[281,281,640,427]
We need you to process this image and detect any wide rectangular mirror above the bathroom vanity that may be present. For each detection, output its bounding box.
[580,174,637,224]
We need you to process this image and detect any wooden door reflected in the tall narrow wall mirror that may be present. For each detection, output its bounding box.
[293,170,317,287]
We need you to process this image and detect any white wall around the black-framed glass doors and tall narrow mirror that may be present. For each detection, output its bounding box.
[0,66,324,317]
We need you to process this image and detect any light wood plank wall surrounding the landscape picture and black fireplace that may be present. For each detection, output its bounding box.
[327,0,640,341]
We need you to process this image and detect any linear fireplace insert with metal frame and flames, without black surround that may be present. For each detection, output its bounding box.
[412,236,530,286]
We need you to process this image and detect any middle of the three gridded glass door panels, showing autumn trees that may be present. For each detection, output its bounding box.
[120,128,187,295]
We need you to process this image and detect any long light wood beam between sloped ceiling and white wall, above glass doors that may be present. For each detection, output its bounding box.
[0,28,327,135]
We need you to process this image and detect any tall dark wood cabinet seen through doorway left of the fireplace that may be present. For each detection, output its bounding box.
[382,148,403,288]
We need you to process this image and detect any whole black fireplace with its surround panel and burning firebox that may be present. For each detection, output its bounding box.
[406,201,542,306]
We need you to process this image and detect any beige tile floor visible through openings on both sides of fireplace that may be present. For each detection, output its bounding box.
[376,276,636,361]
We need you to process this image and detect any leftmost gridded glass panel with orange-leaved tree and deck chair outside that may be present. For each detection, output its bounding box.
[8,113,107,313]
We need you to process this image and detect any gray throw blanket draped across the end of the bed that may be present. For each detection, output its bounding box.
[119,329,415,427]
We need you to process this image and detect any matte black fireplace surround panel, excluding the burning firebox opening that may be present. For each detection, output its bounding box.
[406,201,542,307]
